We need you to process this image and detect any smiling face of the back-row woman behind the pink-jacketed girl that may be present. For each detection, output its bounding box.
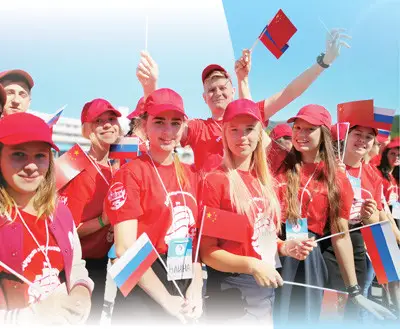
[92,111,121,145]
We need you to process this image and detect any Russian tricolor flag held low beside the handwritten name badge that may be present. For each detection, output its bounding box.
[108,233,157,297]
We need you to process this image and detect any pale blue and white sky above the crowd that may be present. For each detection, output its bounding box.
[0,0,400,120]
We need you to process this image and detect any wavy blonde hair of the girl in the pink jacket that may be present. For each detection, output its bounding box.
[0,144,56,220]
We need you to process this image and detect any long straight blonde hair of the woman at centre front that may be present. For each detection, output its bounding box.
[222,123,281,230]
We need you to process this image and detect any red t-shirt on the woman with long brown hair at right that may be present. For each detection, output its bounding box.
[276,162,353,235]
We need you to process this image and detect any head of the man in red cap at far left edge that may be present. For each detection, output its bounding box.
[0,70,34,116]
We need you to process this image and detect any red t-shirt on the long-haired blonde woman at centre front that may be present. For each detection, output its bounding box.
[203,168,277,264]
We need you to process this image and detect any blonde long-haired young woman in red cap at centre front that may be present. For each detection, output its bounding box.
[200,99,313,325]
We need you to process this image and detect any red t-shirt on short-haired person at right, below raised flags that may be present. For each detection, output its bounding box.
[346,163,382,224]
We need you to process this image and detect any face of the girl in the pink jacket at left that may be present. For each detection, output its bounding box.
[0,142,51,194]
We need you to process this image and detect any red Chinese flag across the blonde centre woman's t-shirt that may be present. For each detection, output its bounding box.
[201,206,249,243]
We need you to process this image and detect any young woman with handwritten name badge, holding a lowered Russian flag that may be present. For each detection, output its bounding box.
[105,89,203,324]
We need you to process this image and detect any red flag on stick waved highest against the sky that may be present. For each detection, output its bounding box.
[250,9,297,59]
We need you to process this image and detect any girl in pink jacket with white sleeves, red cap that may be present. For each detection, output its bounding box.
[0,113,93,325]
